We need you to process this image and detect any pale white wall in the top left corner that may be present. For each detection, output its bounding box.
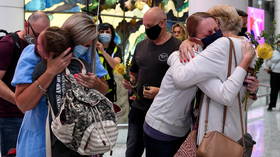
[0,0,24,32]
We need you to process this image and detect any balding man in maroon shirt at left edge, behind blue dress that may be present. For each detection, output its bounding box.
[0,12,50,155]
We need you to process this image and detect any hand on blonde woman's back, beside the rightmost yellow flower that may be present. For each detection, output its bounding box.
[239,41,256,70]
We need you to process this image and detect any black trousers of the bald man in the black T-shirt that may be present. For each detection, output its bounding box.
[125,107,146,157]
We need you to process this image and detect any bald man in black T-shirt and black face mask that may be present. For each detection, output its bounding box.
[124,7,180,157]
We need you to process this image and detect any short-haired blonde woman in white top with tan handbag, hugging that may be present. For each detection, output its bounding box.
[177,5,258,143]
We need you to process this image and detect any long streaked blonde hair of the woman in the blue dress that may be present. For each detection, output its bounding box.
[62,13,98,45]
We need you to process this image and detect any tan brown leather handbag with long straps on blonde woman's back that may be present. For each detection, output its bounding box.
[197,39,244,157]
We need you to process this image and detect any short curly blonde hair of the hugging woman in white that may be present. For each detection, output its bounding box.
[208,5,242,34]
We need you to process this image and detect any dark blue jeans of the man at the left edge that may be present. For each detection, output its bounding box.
[0,118,22,155]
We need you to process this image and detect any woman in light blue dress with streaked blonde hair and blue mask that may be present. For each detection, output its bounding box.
[12,13,108,157]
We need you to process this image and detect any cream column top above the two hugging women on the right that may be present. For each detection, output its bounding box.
[189,0,248,15]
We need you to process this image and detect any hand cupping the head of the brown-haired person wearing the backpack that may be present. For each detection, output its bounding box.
[46,48,72,76]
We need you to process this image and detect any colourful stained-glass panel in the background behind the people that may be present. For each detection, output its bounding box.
[25,0,189,123]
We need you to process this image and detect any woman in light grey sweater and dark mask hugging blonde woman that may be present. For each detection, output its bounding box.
[144,9,254,157]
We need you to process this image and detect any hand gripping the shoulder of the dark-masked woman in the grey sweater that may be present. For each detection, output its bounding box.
[179,40,198,63]
